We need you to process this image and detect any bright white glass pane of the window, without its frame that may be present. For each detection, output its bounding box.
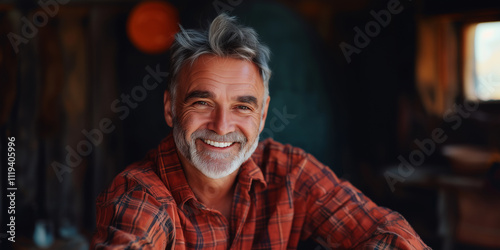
[473,22,500,101]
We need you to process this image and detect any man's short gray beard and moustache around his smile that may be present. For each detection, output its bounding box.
[173,119,259,179]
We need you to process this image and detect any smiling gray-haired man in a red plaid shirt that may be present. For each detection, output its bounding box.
[92,14,428,249]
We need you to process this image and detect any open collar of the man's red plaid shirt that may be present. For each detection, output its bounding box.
[149,133,267,206]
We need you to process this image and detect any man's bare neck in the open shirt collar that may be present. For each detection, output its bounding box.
[179,154,238,220]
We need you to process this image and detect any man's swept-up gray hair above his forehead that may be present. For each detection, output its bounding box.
[167,14,271,98]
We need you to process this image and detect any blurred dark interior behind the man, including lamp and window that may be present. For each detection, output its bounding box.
[0,0,500,249]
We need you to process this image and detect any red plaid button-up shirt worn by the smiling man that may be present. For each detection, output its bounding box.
[92,135,428,249]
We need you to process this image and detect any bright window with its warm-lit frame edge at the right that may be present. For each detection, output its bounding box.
[464,21,500,101]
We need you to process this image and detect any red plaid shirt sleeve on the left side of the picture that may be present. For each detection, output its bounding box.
[91,180,175,249]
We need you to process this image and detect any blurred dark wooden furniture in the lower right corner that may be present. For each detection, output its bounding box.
[387,146,500,250]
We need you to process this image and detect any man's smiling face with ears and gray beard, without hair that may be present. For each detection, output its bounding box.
[165,55,269,179]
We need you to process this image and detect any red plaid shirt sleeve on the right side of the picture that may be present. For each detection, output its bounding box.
[301,155,430,249]
